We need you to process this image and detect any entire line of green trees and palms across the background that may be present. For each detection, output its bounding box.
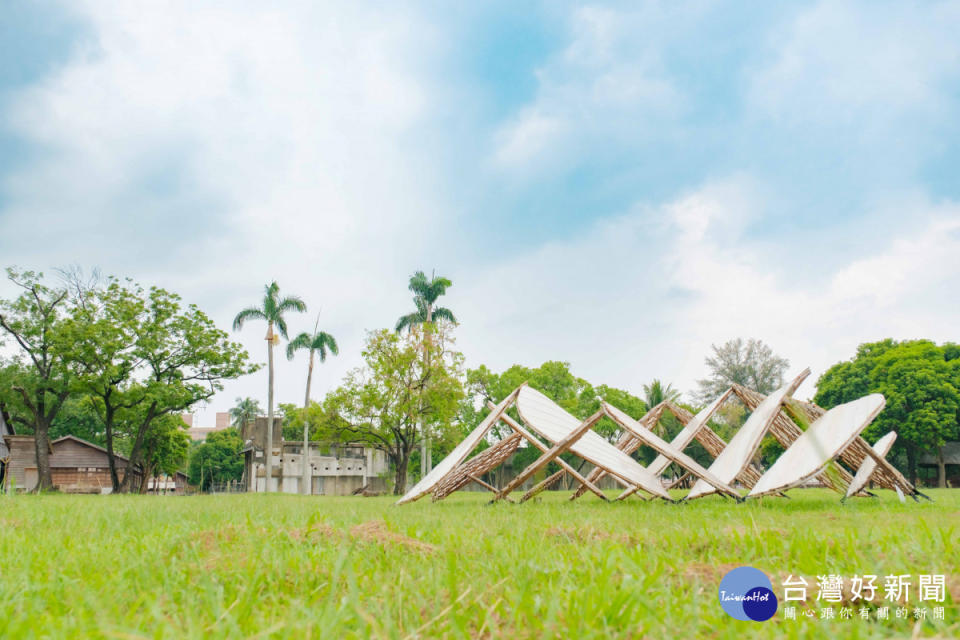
[0,262,960,493]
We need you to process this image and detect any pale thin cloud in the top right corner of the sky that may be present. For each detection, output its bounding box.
[749,2,960,126]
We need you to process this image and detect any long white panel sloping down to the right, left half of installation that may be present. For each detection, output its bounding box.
[517,387,670,500]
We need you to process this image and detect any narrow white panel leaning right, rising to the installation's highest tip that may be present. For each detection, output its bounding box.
[687,369,810,499]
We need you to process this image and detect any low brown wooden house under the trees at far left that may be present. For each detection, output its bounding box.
[2,435,140,493]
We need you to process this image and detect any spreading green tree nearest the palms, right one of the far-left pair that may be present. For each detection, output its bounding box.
[68,278,258,492]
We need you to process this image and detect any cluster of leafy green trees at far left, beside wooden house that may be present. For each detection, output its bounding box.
[0,268,258,492]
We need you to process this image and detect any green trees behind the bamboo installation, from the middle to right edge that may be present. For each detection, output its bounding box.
[282,332,960,493]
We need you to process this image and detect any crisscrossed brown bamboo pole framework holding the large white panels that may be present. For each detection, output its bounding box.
[397,370,930,505]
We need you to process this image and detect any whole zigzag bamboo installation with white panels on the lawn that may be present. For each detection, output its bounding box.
[397,370,929,504]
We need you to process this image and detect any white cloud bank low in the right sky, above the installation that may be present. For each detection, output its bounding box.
[461,176,960,395]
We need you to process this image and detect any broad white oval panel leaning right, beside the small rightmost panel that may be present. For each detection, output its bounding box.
[748,393,886,496]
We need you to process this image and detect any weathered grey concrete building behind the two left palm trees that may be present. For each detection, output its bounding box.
[242,417,389,496]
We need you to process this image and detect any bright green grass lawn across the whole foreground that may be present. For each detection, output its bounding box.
[0,490,960,638]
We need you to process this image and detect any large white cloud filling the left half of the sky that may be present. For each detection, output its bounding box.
[0,2,453,424]
